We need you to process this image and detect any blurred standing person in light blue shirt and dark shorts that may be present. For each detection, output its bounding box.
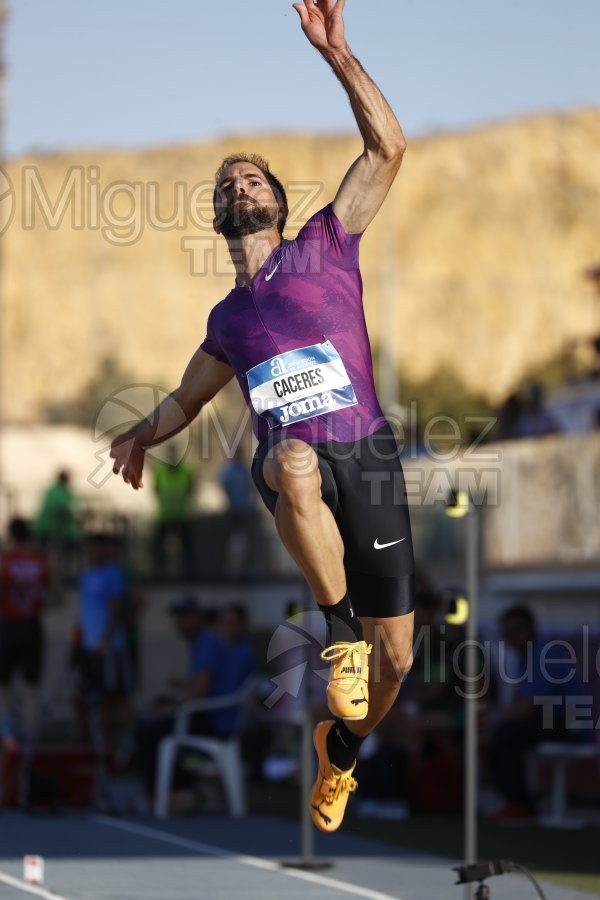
[72,533,135,805]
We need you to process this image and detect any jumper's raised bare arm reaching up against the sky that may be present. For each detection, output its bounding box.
[293,0,406,234]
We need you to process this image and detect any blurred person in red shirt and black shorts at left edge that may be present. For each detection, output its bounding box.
[0,518,54,805]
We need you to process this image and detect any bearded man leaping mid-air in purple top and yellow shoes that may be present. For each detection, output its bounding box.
[111,0,414,831]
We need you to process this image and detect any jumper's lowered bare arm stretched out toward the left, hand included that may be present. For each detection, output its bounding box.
[110,350,233,490]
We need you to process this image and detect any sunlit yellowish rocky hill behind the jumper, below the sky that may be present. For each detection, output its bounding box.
[0,109,600,423]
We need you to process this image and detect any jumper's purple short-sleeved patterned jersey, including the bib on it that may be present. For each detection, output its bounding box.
[201,204,385,444]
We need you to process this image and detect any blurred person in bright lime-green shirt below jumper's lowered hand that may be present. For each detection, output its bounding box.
[154,444,196,578]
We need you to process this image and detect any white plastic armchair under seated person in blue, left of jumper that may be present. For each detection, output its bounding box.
[154,677,257,819]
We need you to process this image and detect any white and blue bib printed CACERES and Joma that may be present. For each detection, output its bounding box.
[246,341,358,428]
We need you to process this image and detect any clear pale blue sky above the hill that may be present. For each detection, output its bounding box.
[5,0,600,157]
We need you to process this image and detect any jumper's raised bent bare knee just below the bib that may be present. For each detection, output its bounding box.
[263,439,320,506]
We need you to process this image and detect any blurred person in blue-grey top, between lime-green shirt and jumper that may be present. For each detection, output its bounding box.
[220,445,256,577]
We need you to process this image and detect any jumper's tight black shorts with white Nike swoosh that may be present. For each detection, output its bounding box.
[252,426,414,618]
